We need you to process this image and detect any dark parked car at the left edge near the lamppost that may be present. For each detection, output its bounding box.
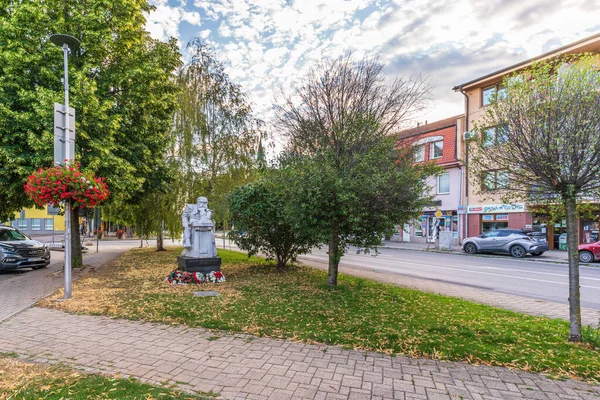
[0,226,50,270]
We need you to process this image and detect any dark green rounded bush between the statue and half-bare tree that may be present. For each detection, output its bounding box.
[229,169,318,269]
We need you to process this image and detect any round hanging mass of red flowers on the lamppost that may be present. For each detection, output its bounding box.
[24,163,109,207]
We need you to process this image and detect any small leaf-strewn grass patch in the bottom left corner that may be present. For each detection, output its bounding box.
[0,354,208,400]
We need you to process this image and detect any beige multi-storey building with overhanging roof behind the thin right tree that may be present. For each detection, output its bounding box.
[453,34,600,248]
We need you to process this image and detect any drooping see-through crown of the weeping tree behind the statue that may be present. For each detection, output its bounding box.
[173,38,262,228]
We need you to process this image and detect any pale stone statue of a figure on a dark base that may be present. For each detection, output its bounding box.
[181,197,217,258]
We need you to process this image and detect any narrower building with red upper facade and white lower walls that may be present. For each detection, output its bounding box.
[398,116,464,243]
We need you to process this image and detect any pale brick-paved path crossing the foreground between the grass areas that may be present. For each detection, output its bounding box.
[0,308,600,400]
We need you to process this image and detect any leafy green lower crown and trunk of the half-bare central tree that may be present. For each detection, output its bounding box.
[281,137,438,285]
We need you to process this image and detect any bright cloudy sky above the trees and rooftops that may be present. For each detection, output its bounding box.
[147,0,600,137]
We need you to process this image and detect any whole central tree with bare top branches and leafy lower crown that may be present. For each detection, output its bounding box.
[276,54,434,285]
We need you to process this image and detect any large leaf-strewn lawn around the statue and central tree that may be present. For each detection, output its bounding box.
[41,249,600,381]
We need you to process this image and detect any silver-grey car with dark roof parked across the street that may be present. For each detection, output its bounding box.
[463,229,550,258]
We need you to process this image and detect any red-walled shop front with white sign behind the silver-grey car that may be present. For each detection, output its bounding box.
[467,203,533,236]
